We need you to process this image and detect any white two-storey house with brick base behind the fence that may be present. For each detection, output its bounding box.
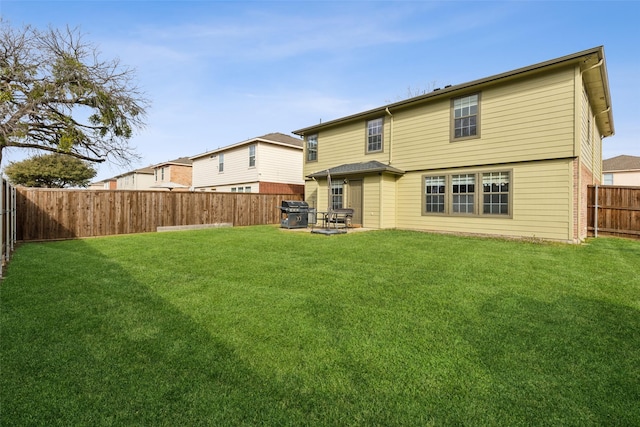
[191,133,304,194]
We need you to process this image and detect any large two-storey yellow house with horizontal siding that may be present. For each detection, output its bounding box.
[293,47,614,244]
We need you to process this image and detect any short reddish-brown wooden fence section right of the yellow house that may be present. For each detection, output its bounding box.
[587,185,640,239]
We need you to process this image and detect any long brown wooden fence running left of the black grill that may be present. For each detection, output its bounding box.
[17,188,302,241]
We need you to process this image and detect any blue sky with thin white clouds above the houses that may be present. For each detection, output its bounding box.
[0,0,640,180]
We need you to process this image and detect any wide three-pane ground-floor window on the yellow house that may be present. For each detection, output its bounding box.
[423,171,512,216]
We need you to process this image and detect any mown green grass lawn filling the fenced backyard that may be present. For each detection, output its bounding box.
[0,226,640,426]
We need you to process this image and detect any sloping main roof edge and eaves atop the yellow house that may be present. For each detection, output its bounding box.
[293,46,614,140]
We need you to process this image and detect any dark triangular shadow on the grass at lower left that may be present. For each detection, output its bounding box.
[0,241,320,426]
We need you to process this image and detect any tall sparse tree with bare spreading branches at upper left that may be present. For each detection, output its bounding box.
[0,18,148,165]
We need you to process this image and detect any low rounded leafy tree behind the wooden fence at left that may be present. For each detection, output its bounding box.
[4,153,96,188]
